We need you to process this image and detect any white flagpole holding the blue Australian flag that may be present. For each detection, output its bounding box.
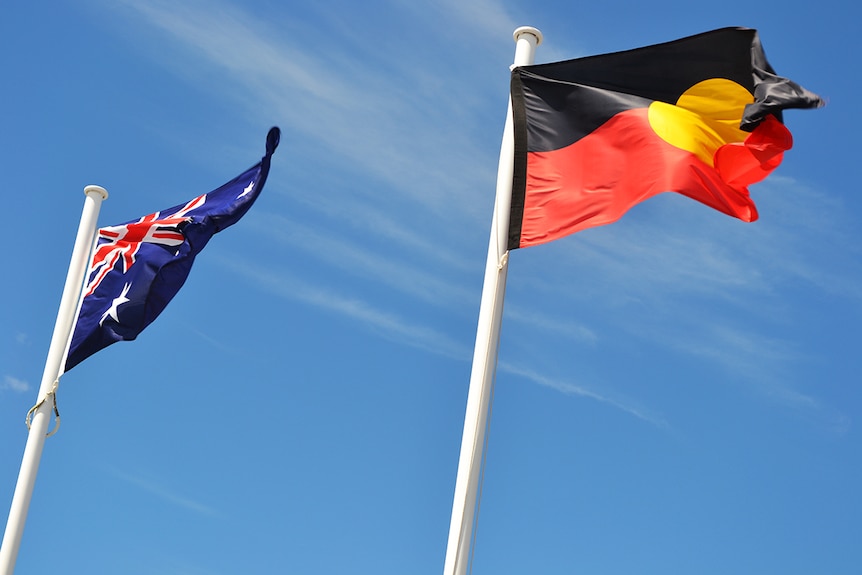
[0,186,108,575]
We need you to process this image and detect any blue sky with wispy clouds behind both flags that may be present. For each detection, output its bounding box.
[0,0,862,575]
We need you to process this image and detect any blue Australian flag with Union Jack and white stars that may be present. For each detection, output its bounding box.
[64,128,280,371]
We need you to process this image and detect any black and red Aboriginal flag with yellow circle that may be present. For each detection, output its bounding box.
[508,28,823,249]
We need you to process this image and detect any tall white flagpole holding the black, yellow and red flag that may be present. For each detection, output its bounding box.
[443,26,542,575]
